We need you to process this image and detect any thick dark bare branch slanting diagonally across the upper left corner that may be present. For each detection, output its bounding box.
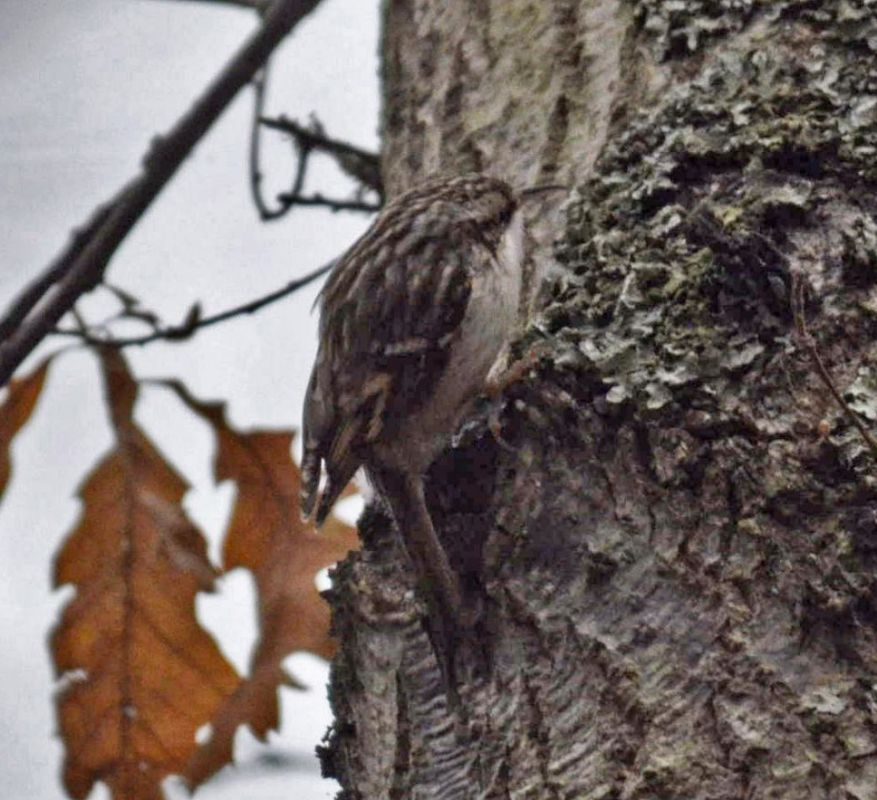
[0,0,320,386]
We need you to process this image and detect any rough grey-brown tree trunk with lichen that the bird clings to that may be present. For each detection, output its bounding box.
[323,0,877,800]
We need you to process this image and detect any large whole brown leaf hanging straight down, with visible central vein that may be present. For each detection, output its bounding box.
[52,352,239,800]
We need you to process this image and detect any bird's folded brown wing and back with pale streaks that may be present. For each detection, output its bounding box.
[302,217,494,523]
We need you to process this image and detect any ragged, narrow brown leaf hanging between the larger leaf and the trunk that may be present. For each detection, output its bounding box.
[167,382,359,786]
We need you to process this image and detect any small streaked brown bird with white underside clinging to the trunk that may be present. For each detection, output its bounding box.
[301,173,544,626]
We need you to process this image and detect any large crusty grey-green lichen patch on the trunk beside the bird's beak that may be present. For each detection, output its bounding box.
[545,3,877,444]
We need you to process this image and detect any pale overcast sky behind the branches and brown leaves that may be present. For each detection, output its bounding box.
[0,0,378,800]
